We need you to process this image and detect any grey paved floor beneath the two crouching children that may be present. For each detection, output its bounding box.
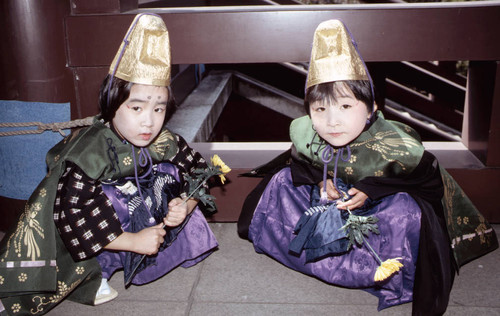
[39,223,500,316]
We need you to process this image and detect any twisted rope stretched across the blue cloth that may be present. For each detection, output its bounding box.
[0,116,94,137]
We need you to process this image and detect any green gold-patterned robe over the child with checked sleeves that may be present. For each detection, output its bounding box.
[0,118,178,315]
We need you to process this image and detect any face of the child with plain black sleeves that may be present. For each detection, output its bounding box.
[309,89,370,147]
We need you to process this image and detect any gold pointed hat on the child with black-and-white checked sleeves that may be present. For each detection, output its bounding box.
[109,14,171,86]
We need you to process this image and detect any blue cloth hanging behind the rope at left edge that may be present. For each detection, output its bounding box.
[0,100,71,200]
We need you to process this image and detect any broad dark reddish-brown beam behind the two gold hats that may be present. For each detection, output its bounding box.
[66,1,500,67]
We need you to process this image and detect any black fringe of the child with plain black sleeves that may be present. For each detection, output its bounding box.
[304,80,374,115]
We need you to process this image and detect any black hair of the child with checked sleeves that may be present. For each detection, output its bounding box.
[99,74,177,124]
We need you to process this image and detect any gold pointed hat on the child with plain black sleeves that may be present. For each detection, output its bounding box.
[306,20,370,89]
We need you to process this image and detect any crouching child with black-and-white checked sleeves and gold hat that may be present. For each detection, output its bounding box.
[0,14,217,315]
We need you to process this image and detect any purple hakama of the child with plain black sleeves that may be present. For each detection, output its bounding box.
[249,168,421,310]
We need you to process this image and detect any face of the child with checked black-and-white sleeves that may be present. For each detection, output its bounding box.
[112,84,168,147]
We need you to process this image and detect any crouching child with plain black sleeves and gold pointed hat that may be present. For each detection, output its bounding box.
[238,20,498,315]
